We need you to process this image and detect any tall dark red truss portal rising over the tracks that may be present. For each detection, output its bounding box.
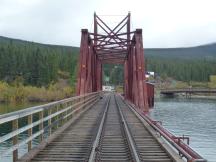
[77,13,154,111]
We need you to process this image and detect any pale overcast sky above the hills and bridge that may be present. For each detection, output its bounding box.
[0,0,216,48]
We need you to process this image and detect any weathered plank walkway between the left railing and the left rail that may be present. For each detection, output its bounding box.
[31,96,108,162]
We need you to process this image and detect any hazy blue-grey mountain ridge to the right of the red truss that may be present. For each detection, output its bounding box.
[144,43,216,59]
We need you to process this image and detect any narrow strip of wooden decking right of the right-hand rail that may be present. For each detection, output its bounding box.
[116,97,175,162]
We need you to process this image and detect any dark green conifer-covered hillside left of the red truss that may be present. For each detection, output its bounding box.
[0,37,79,87]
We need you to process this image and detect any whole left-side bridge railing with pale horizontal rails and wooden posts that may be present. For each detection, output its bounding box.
[0,92,101,161]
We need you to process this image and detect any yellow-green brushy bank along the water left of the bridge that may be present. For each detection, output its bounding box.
[0,82,75,103]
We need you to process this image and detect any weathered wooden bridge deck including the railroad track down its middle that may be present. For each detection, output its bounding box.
[19,94,182,162]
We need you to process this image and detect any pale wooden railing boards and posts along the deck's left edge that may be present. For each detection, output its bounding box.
[0,92,100,161]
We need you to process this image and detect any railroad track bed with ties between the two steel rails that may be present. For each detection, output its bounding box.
[95,95,133,162]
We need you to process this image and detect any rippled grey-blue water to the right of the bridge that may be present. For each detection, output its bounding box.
[150,99,216,162]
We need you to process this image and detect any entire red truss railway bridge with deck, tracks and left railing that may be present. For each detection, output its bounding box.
[0,13,206,162]
